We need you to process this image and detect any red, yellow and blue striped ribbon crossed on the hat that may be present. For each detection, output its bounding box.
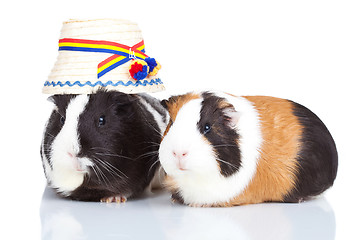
[59,38,148,78]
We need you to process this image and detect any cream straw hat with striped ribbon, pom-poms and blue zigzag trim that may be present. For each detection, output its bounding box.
[43,19,165,94]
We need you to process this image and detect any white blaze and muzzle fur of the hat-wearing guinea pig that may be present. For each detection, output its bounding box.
[42,95,93,196]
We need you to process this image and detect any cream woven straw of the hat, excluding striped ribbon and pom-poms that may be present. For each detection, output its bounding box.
[43,19,164,94]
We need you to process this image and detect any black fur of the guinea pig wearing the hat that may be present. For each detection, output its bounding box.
[40,90,161,201]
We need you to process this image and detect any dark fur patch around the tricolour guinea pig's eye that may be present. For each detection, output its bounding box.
[197,92,241,177]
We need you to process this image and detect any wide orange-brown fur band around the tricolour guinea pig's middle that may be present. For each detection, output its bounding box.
[228,96,302,206]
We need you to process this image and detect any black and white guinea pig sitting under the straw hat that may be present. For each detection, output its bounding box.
[41,90,168,202]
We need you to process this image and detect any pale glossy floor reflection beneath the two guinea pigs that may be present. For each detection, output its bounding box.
[40,188,336,240]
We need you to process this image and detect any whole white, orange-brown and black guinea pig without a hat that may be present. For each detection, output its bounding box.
[159,92,338,206]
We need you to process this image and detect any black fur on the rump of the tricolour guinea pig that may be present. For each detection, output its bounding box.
[284,102,338,202]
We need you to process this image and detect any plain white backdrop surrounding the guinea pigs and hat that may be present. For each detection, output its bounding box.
[0,0,360,239]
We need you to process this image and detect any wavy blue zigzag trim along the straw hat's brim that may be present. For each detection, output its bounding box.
[44,78,163,87]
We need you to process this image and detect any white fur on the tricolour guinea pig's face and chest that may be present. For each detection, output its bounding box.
[159,93,262,204]
